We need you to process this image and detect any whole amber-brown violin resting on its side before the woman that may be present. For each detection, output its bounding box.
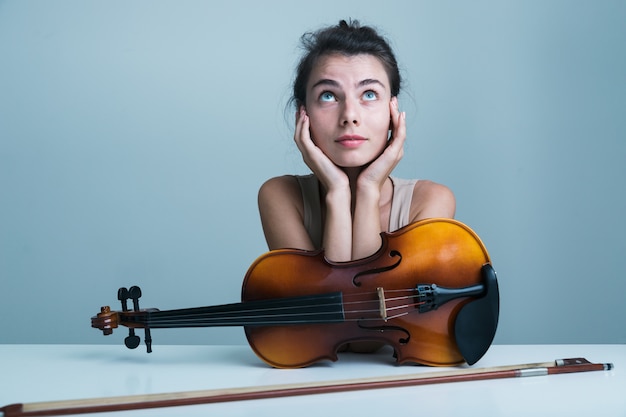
[91,219,499,368]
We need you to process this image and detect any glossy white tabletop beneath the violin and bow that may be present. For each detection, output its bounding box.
[0,345,626,417]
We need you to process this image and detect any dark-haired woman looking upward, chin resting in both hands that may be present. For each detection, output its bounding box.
[259,21,455,262]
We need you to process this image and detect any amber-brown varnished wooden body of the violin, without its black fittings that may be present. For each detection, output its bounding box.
[242,219,498,367]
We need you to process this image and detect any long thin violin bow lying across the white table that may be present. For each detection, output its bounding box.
[0,358,613,417]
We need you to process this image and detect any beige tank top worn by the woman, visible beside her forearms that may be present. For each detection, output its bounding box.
[296,174,418,248]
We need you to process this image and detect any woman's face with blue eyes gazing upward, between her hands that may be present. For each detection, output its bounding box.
[306,54,391,168]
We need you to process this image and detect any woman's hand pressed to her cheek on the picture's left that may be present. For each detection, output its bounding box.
[294,107,350,192]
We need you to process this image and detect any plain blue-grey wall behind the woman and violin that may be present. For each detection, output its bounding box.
[0,0,626,345]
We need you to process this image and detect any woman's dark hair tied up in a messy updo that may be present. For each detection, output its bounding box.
[291,20,401,107]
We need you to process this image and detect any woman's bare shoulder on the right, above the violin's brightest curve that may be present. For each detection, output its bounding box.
[411,180,456,221]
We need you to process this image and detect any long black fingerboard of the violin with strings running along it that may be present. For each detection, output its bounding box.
[129,292,345,329]
